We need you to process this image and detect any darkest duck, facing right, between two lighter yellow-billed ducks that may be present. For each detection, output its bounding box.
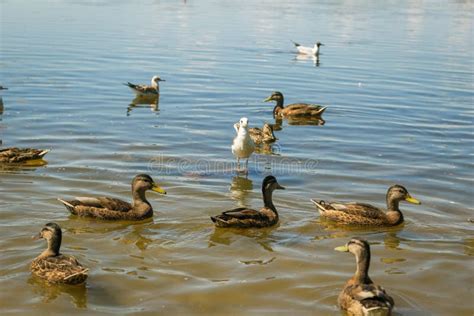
[211,176,285,228]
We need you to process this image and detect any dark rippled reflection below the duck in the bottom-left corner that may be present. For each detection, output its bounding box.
[28,276,87,308]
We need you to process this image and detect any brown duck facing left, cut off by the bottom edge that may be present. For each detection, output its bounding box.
[335,238,395,315]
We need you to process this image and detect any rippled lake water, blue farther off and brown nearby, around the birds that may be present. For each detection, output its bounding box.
[0,0,474,315]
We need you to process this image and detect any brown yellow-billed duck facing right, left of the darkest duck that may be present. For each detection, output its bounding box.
[58,174,166,220]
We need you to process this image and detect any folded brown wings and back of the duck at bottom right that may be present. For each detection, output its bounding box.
[344,284,395,312]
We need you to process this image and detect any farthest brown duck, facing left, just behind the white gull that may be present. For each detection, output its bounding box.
[264,91,326,118]
